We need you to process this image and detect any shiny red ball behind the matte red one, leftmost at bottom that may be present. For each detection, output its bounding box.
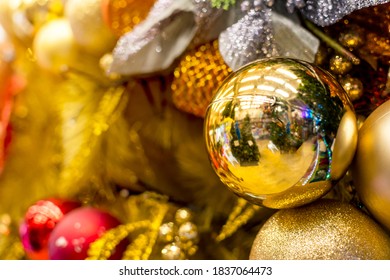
[19,198,81,260]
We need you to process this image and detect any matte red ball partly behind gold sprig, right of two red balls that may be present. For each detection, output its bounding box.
[49,207,128,260]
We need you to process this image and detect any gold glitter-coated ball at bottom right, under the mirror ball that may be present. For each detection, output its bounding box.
[249,199,390,260]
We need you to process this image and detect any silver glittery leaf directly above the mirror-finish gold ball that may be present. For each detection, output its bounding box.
[219,3,319,70]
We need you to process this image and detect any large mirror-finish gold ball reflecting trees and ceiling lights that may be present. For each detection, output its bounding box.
[204,58,357,209]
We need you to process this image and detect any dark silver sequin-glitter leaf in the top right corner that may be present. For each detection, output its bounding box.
[301,0,390,26]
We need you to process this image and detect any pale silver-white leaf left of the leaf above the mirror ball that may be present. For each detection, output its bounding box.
[109,0,196,75]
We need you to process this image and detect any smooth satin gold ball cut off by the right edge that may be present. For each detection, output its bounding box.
[352,101,390,229]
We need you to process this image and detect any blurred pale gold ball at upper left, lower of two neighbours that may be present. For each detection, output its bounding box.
[33,19,78,72]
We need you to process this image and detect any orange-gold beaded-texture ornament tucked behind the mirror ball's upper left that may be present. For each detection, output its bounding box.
[171,41,232,117]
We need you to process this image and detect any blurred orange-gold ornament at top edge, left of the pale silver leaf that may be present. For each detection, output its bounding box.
[102,0,156,36]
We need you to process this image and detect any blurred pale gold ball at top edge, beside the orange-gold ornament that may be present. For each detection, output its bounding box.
[65,0,116,55]
